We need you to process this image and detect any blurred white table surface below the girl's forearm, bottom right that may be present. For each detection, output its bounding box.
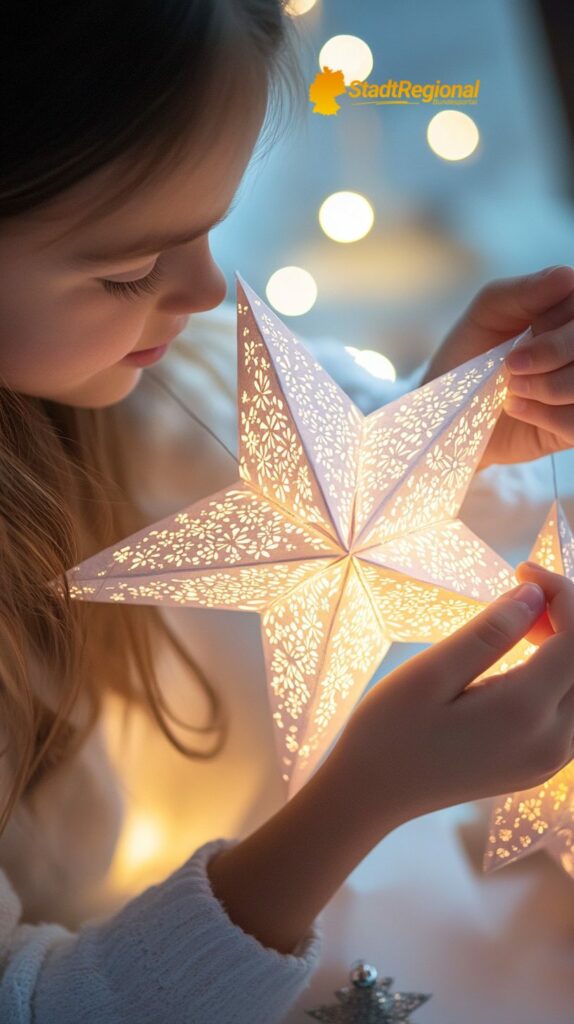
[285,801,574,1024]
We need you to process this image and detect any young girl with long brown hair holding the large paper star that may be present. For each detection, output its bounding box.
[0,0,574,1024]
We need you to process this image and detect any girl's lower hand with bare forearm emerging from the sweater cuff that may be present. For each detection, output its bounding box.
[209,562,574,952]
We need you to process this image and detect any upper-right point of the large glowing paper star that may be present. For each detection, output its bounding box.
[356,360,506,545]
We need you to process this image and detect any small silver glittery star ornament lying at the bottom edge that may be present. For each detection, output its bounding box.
[305,964,431,1024]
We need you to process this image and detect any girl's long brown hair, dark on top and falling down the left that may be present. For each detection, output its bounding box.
[0,0,304,833]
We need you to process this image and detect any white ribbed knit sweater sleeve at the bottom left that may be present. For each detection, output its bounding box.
[0,839,320,1024]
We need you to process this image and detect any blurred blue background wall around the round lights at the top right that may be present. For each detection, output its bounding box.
[212,0,574,374]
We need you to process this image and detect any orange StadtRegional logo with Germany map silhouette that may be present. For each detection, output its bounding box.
[309,68,480,116]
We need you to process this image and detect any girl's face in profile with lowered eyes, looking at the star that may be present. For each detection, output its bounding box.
[0,109,263,408]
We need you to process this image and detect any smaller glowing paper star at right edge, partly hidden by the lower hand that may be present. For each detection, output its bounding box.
[484,502,574,878]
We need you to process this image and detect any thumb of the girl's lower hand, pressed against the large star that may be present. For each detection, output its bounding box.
[420,583,546,700]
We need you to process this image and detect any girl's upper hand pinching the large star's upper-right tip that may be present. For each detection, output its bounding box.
[425,266,574,469]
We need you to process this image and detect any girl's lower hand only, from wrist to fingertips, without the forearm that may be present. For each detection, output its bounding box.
[334,562,574,842]
